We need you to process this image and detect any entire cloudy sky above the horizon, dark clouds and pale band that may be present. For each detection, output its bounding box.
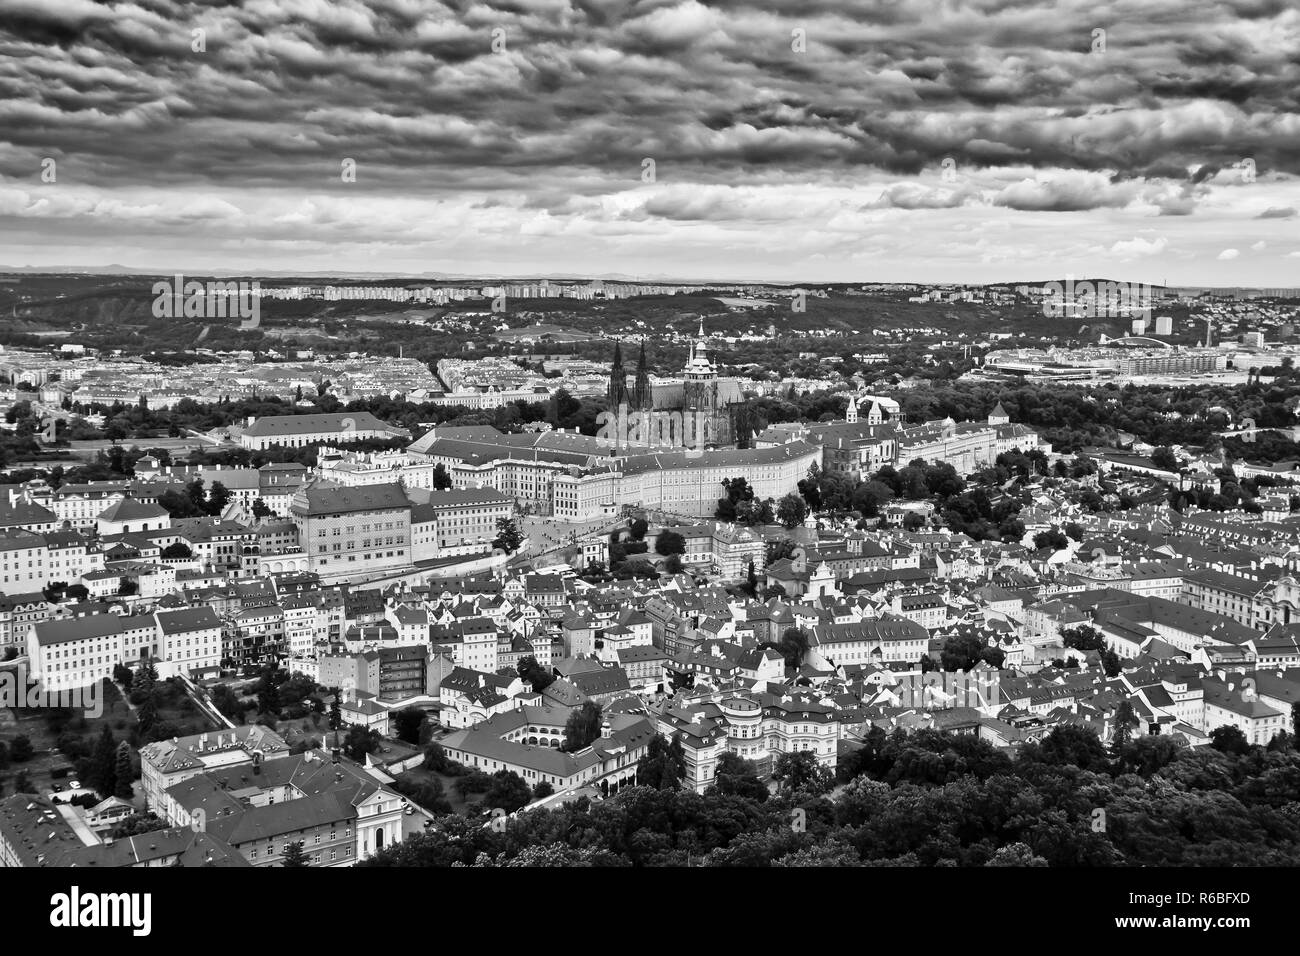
[0,0,1300,286]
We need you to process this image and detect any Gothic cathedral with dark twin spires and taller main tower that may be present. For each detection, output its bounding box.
[606,321,751,449]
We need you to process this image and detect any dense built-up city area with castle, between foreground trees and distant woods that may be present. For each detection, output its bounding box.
[0,321,1300,868]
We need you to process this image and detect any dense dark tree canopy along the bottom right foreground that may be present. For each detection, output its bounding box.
[361,727,1300,866]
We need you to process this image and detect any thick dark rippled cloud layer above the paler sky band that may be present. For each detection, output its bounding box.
[0,0,1300,195]
